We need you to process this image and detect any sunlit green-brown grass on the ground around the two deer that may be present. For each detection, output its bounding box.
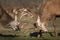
[0,15,60,40]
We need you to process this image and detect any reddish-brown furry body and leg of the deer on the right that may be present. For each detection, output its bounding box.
[40,0,60,34]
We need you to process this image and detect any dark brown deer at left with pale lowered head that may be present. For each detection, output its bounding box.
[0,5,19,30]
